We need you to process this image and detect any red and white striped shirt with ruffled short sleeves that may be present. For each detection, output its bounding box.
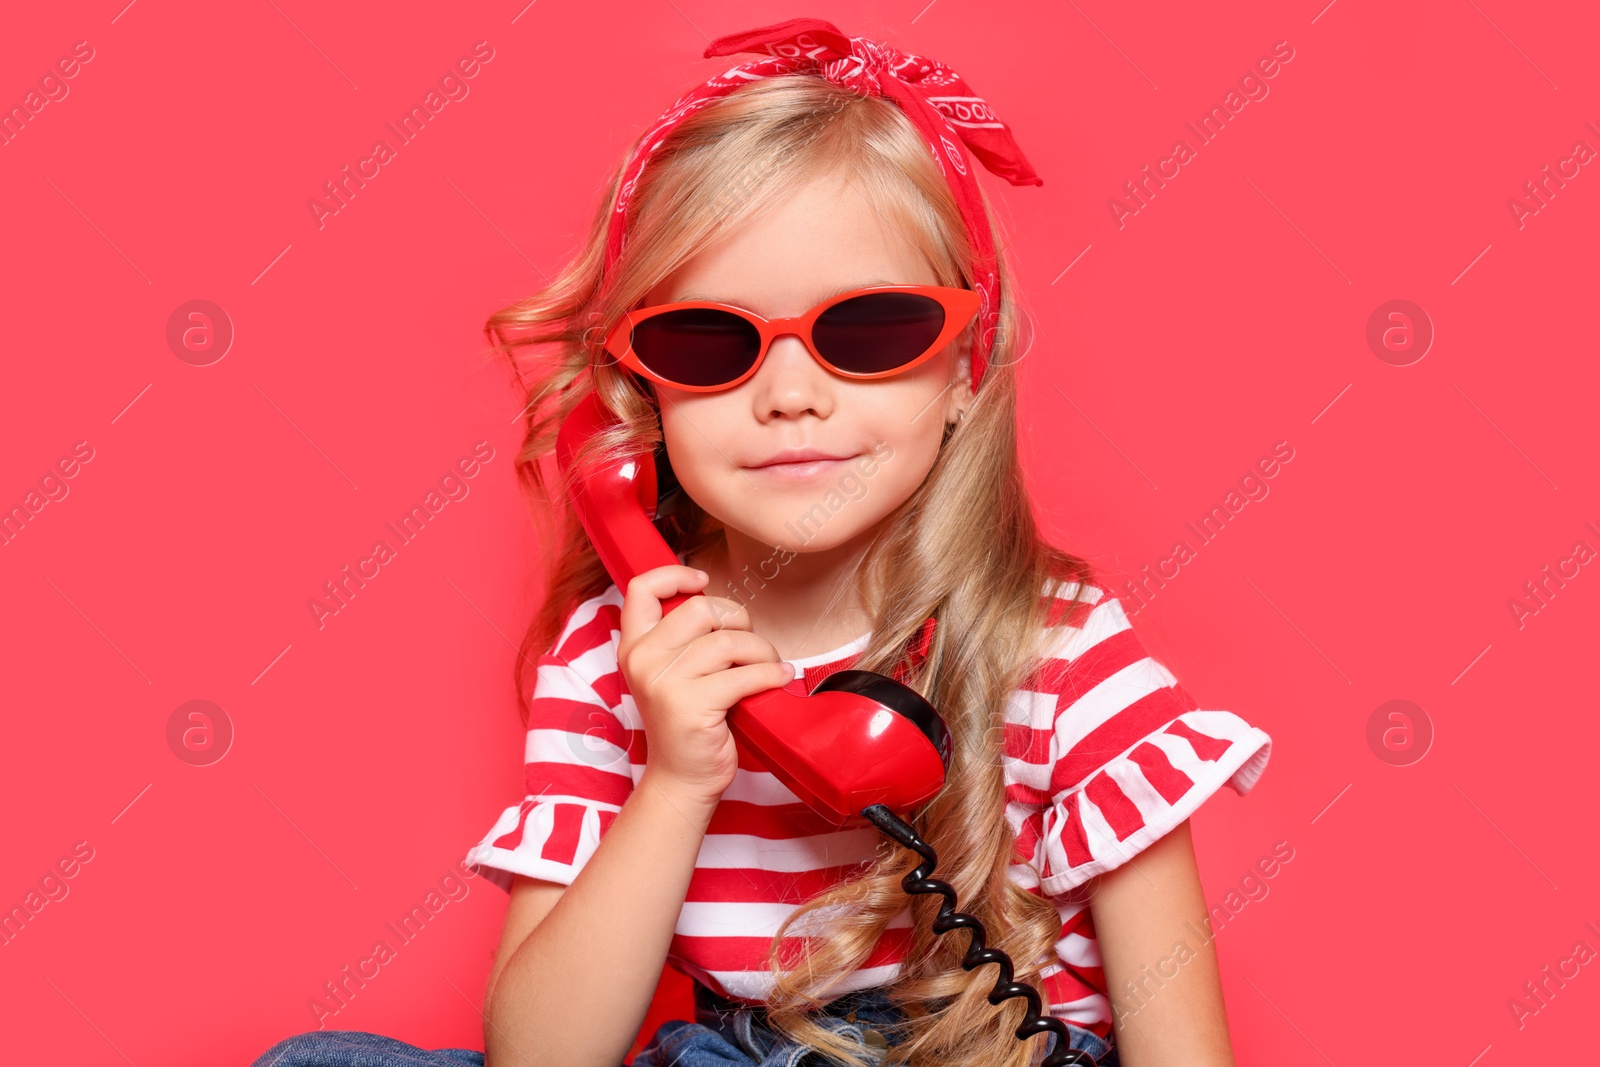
[466,584,1272,1037]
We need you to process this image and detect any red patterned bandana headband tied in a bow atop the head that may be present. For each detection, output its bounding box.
[605,19,1045,392]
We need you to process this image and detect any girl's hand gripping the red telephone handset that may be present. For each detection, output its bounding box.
[618,565,794,805]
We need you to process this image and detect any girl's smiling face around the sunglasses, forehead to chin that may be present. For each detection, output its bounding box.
[645,178,971,552]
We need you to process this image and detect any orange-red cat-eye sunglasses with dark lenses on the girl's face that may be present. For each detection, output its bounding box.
[605,285,979,392]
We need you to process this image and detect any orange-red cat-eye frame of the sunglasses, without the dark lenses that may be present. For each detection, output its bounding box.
[605,285,981,392]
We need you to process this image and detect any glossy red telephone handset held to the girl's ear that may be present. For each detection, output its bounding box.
[555,394,950,827]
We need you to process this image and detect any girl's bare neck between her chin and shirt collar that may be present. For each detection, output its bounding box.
[690,528,872,659]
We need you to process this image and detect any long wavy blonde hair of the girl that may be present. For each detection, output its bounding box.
[485,75,1090,1067]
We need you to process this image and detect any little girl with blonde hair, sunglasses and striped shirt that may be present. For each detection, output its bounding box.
[258,19,1270,1067]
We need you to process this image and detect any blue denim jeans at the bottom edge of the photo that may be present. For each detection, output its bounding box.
[251,982,1118,1067]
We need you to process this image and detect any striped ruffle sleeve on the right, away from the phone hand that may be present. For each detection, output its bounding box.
[1034,597,1272,896]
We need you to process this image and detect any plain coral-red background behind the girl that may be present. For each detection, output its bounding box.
[0,0,1600,1067]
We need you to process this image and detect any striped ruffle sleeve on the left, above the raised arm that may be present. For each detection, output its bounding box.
[464,607,634,891]
